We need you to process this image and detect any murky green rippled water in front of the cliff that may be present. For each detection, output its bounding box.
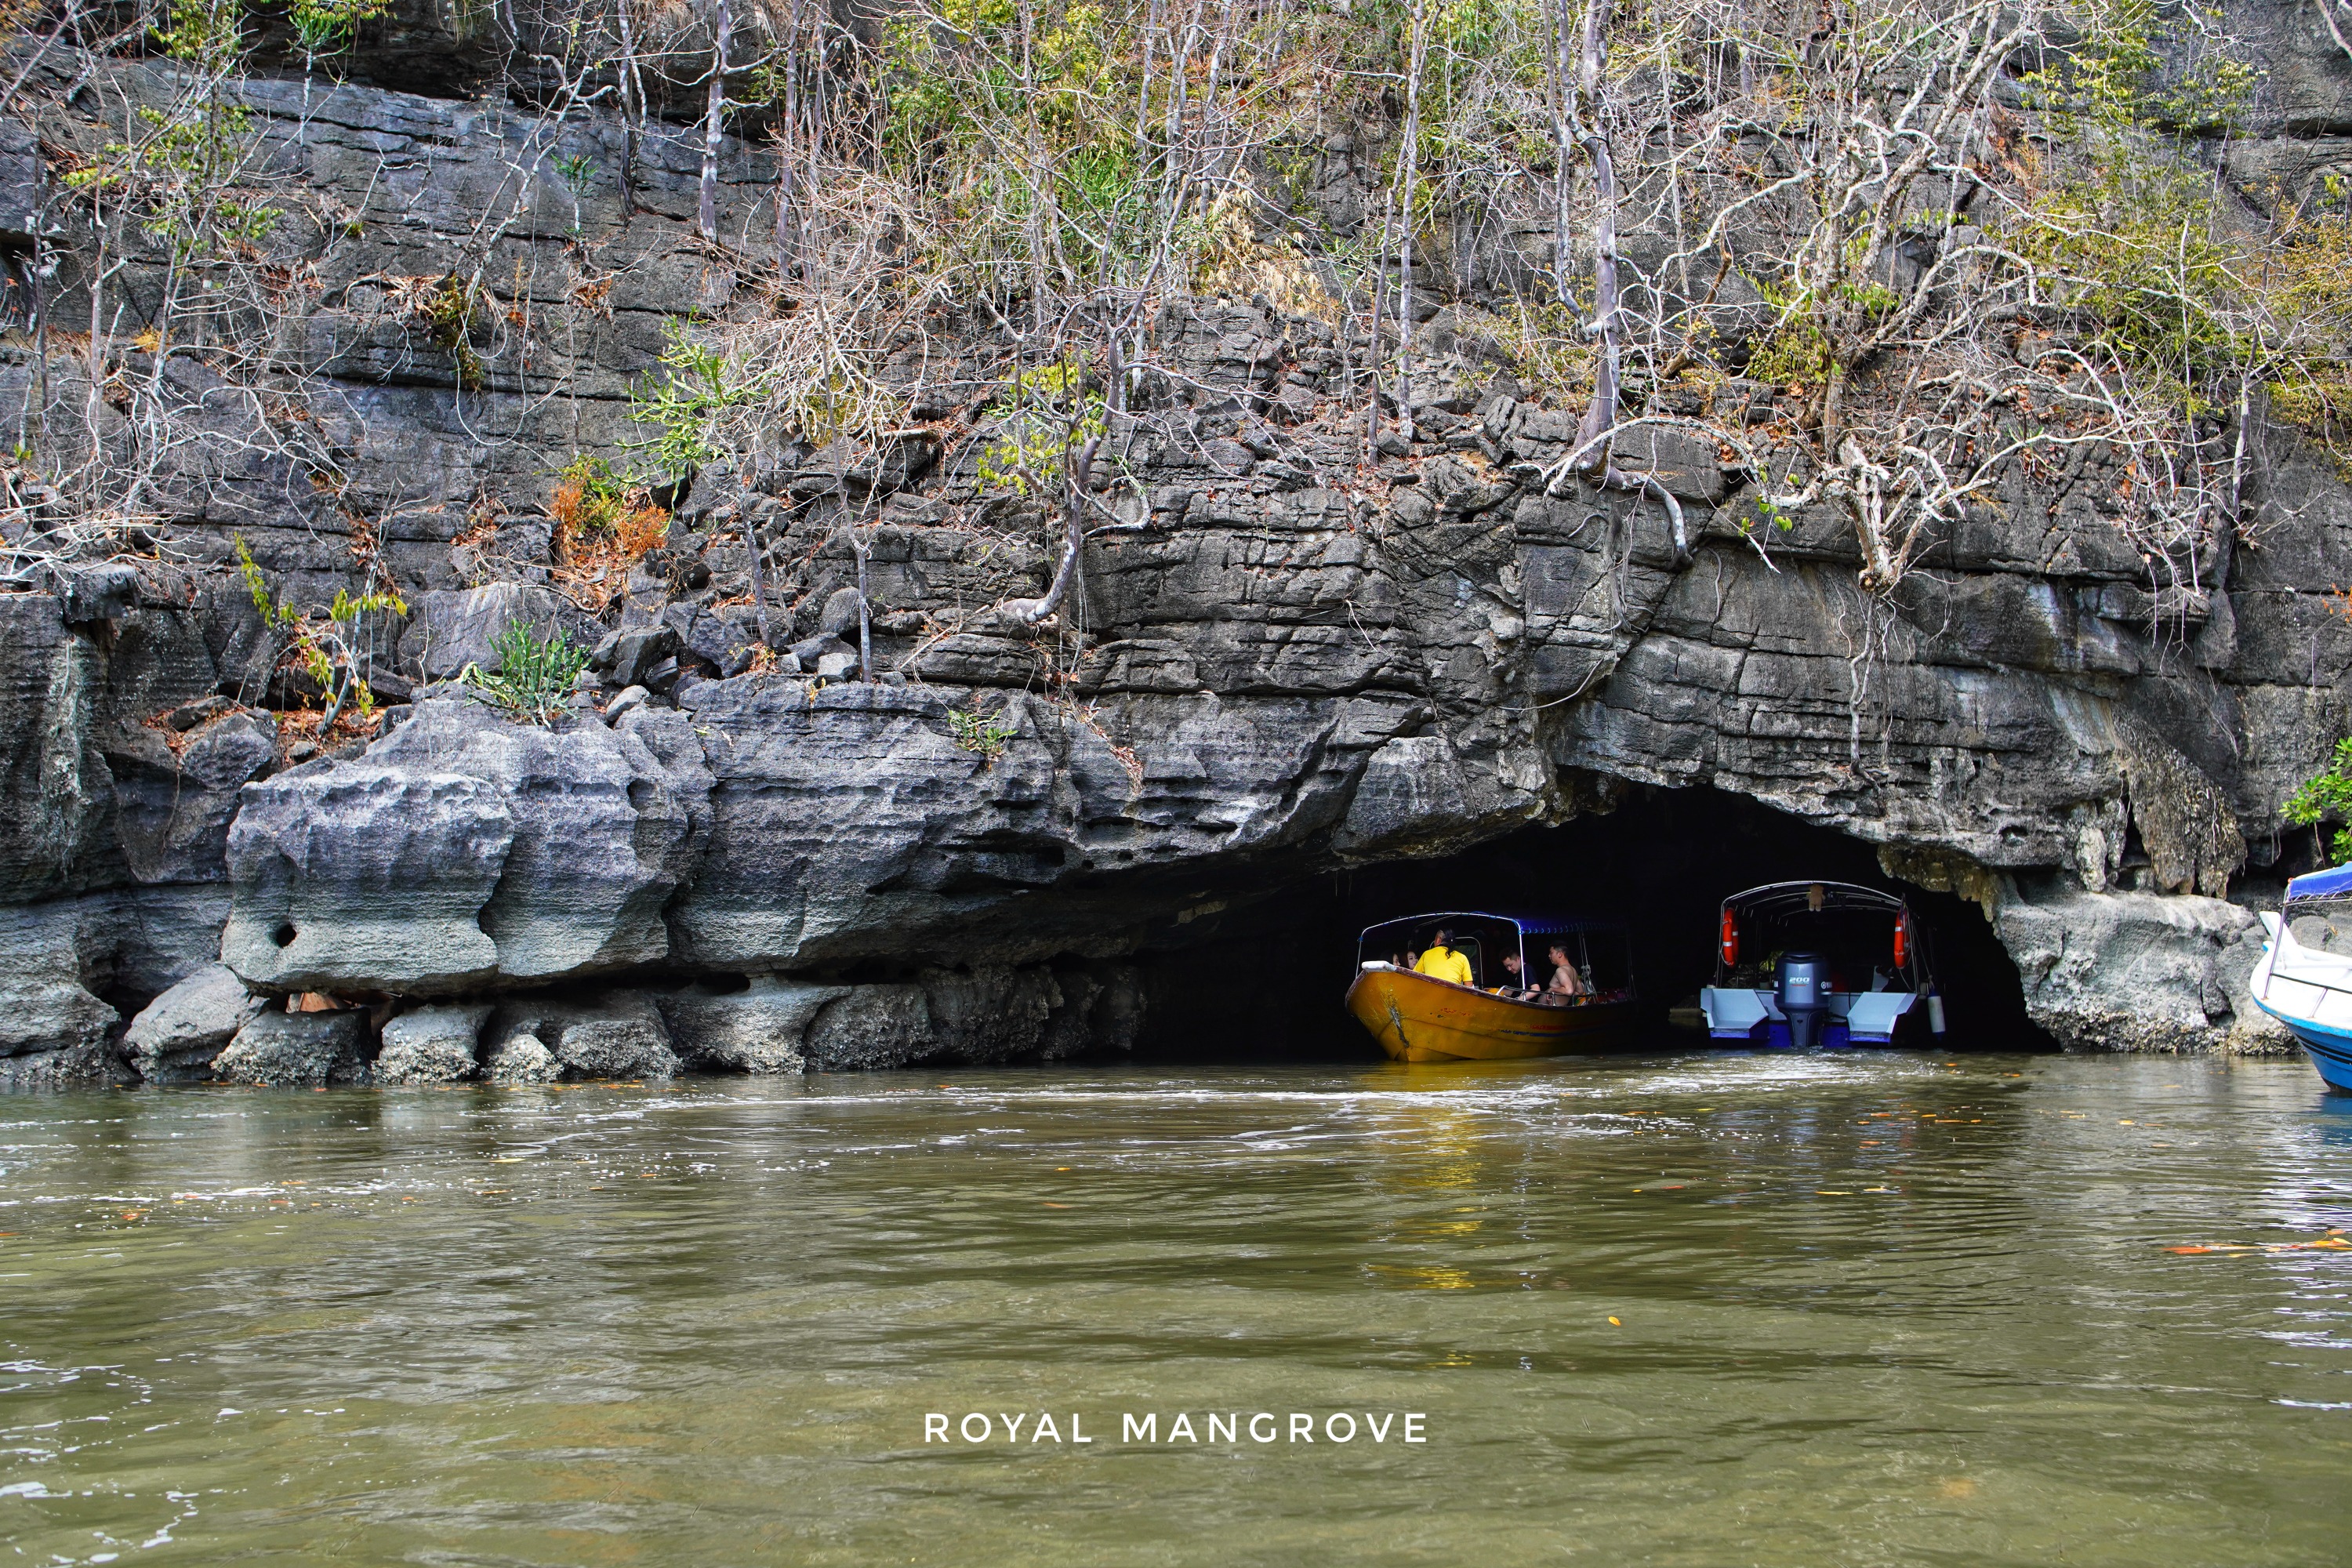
[0,1053,2352,1568]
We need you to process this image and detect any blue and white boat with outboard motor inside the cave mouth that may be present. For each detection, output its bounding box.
[1698,881,1943,1051]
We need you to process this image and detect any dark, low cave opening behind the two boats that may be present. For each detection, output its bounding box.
[1134,785,2053,1065]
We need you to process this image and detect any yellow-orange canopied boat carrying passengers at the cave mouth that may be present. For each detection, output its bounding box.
[1348,912,1635,1062]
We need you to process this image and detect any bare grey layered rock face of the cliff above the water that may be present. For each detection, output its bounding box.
[0,5,2352,1083]
